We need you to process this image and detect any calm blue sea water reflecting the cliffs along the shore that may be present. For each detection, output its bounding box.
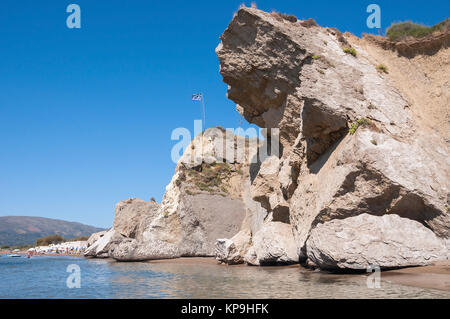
[0,256,450,298]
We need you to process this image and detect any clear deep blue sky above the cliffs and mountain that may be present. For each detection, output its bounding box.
[0,0,450,227]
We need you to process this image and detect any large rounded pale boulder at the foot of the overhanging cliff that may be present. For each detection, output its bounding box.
[306,214,447,270]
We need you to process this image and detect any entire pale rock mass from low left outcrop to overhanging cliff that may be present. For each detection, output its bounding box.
[86,8,450,270]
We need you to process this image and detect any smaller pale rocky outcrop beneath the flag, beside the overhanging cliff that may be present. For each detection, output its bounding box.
[109,128,264,261]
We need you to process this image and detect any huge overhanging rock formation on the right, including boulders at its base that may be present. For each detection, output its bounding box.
[216,8,450,269]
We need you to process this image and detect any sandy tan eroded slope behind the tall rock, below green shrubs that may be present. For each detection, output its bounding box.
[356,32,450,143]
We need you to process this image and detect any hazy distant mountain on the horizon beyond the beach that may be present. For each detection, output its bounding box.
[0,216,104,246]
